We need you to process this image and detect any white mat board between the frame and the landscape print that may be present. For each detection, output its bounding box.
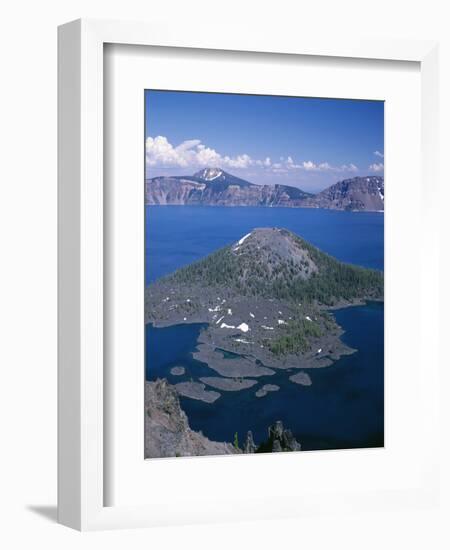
[105,46,426,512]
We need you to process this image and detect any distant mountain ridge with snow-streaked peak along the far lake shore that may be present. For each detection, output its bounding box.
[145,168,384,211]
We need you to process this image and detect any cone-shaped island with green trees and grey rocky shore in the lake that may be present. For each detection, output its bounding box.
[145,228,383,378]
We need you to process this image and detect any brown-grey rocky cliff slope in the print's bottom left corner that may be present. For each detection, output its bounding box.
[145,379,241,458]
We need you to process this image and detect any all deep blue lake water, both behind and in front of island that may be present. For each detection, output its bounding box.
[146,206,384,450]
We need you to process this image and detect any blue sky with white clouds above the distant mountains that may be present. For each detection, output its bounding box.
[145,90,384,191]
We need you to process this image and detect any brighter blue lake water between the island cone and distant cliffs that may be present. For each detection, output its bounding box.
[145,206,384,284]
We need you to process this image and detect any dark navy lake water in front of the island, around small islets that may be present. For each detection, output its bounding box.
[147,302,384,450]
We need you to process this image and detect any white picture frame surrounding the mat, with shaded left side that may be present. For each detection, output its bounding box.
[58,20,439,530]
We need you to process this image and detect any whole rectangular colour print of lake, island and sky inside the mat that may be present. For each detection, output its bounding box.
[144,90,384,459]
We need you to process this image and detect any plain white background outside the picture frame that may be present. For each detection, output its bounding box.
[0,0,450,549]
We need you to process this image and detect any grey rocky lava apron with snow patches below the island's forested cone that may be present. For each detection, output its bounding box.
[146,284,356,386]
